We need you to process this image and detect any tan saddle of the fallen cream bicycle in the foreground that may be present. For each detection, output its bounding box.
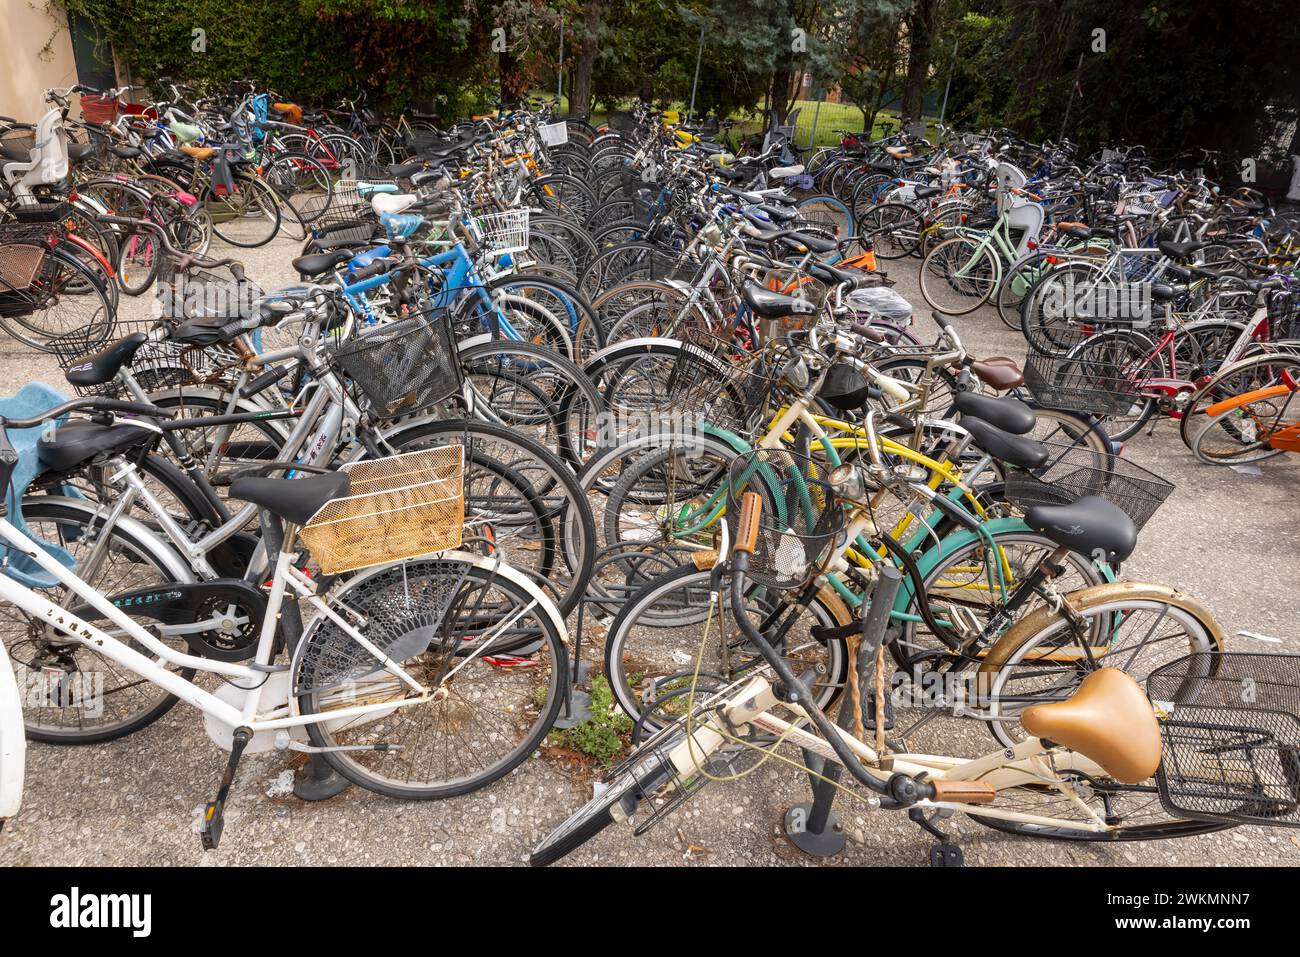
[1021,668,1161,784]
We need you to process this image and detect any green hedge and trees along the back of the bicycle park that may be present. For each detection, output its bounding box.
[48,0,1300,163]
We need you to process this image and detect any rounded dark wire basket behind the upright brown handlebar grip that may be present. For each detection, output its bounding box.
[727,449,844,588]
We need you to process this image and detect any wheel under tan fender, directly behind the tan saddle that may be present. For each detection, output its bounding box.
[979,581,1223,748]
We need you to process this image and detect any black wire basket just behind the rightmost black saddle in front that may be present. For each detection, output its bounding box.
[1005,442,1174,529]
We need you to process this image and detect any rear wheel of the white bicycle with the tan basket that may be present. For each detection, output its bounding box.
[293,553,568,800]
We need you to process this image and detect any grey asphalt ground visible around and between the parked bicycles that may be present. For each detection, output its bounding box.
[0,234,1300,866]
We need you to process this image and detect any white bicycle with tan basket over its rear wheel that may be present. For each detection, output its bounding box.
[0,399,568,849]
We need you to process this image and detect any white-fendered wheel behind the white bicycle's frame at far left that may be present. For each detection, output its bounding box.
[0,495,194,744]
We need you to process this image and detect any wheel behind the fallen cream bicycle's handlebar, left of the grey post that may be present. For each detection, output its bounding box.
[605,564,853,729]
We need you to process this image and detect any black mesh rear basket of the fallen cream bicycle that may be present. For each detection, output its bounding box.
[1147,651,1300,827]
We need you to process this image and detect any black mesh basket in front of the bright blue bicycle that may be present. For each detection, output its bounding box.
[334,312,462,419]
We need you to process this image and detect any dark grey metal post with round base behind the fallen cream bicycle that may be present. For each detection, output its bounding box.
[783,566,902,857]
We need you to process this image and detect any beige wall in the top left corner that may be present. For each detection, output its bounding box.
[0,0,77,122]
